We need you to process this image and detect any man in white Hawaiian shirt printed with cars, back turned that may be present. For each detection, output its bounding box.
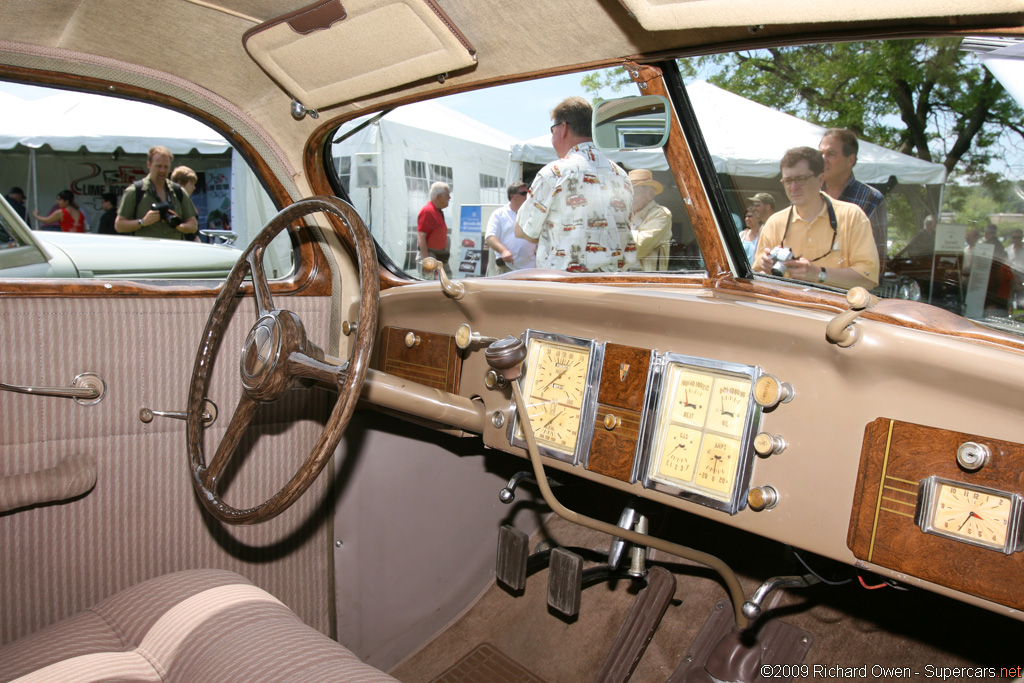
[515,97,637,272]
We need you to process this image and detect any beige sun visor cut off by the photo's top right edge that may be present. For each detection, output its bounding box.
[620,0,1024,31]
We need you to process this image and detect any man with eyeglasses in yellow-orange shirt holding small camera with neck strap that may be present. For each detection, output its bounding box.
[754,147,879,289]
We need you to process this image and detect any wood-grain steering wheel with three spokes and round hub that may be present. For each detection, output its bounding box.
[186,197,379,524]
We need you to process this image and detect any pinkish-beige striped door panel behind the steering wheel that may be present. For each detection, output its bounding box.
[0,297,332,643]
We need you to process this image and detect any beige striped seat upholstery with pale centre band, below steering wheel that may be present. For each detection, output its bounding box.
[0,569,395,683]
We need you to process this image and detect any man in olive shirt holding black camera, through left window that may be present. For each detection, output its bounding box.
[114,146,199,240]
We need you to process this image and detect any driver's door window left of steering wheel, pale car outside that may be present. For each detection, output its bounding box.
[0,84,294,280]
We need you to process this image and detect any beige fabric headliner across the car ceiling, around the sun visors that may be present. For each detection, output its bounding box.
[0,0,1024,193]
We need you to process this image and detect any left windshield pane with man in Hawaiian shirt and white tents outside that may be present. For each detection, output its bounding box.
[332,70,703,279]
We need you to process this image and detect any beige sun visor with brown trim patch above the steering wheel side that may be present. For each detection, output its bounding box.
[242,0,476,110]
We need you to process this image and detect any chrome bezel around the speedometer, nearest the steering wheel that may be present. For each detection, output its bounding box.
[506,330,604,465]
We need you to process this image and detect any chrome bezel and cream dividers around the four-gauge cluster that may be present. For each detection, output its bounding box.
[638,352,764,515]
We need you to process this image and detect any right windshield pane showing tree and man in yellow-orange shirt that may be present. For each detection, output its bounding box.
[679,38,1024,330]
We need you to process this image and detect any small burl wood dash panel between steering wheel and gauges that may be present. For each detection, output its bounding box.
[378,327,462,393]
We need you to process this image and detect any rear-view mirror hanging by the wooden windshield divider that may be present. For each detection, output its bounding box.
[594,95,669,150]
